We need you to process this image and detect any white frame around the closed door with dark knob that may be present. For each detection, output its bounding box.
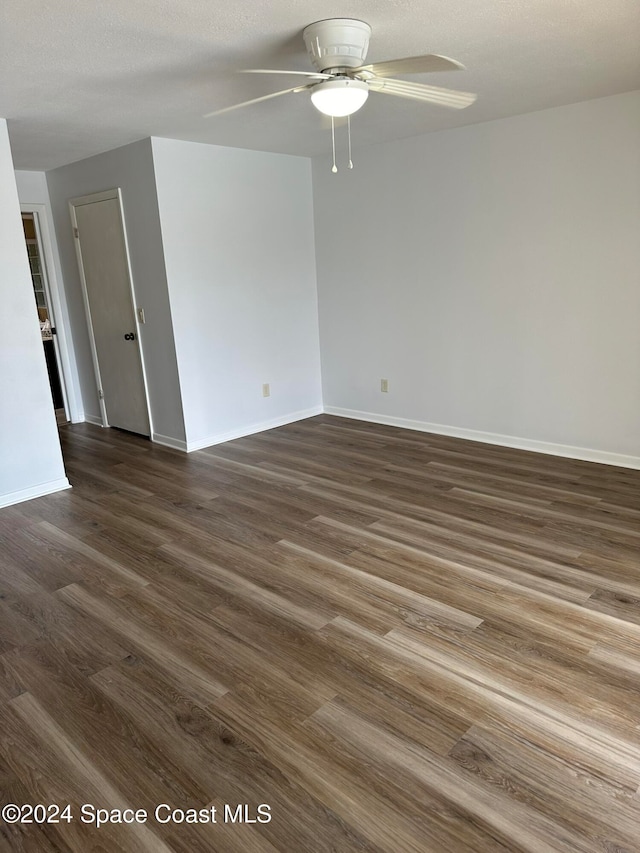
[69,187,153,438]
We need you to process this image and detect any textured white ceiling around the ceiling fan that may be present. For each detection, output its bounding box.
[0,0,640,169]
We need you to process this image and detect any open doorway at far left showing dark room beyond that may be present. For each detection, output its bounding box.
[22,211,69,426]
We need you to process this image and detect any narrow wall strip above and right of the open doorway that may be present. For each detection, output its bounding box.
[15,171,84,422]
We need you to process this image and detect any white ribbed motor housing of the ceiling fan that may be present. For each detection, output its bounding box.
[302,18,371,71]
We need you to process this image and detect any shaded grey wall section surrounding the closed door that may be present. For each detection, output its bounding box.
[47,139,185,446]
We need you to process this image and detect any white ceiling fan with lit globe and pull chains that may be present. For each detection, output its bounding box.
[204,18,476,172]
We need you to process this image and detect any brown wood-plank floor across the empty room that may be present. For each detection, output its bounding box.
[0,416,640,853]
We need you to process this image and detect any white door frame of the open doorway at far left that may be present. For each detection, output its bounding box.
[20,202,82,423]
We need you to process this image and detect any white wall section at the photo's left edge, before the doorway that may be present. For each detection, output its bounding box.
[0,119,69,506]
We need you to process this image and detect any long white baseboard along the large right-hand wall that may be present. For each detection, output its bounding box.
[324,406,640,469]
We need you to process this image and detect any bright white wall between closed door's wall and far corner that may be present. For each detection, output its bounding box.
[152,138,322,449]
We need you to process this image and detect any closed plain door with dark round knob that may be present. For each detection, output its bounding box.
[70,190,150,435]
